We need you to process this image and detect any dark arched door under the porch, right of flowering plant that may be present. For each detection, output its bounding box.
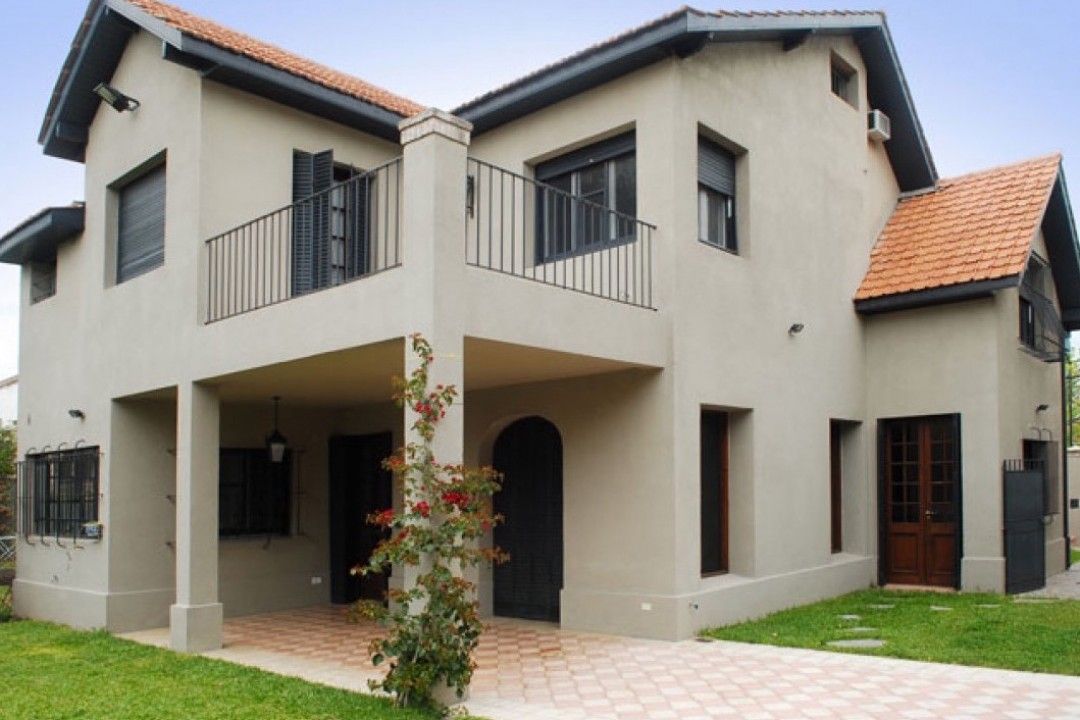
[492,418,563,622]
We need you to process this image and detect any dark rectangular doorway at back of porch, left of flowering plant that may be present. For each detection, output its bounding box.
[329,433,393,602]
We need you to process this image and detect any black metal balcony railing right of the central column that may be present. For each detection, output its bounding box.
[465,158,656,309]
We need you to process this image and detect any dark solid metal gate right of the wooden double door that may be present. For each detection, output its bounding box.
[1003,460,1047,593]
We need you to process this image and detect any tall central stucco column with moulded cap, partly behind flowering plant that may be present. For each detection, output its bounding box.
[394,109,472,586]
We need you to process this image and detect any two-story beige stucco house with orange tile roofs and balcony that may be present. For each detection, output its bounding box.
[0,0,1080,650]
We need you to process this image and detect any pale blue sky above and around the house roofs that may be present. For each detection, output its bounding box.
[0,0,1080,378]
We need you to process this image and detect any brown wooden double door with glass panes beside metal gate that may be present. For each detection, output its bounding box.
[882,417,960,587]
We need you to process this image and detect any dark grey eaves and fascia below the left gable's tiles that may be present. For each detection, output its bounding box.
[38,0,402,162]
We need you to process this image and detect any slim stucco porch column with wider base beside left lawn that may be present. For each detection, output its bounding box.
[170,382,222,652]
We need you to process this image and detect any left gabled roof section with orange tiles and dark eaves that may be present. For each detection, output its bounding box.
[38,0,422,161]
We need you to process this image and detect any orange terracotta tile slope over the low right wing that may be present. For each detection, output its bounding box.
[855,154,1062,300]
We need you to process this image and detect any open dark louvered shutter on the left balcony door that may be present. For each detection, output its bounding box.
[293,150,334,295]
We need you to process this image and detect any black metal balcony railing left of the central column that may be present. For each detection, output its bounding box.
[206,158,402,323]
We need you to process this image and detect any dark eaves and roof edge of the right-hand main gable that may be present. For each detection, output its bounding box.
[454,8,937,191]
